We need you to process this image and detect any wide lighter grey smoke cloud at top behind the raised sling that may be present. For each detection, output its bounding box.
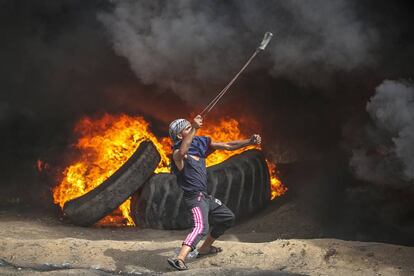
[98,0,376,102]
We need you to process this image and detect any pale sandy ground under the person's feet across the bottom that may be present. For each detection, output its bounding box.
[0,205,414,275]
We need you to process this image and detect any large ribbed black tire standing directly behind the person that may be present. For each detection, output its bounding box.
[131,150,270,229]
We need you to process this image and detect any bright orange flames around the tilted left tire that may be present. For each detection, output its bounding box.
[53,114,168,226]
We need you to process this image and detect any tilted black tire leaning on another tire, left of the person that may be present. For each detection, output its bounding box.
[63,141,161,226]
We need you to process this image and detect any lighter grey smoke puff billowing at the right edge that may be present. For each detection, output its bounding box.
[350,80,414,189]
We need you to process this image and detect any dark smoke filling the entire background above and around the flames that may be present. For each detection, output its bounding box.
[0,0,414,243]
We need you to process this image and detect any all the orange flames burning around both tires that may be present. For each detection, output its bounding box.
[53,114,286,226]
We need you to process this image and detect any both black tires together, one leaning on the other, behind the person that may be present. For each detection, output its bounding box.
[63,141,270,229]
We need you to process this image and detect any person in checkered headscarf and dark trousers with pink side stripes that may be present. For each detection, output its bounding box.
[168,115,261,270]
